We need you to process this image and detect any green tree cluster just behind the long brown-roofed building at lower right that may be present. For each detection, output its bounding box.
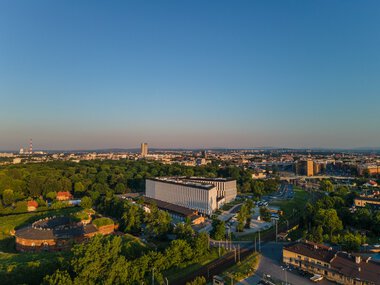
[300,183,380,248]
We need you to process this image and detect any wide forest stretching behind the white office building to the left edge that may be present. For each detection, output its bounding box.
[0,160,279,213]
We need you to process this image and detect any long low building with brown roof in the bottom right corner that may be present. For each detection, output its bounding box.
[283,241,380,285]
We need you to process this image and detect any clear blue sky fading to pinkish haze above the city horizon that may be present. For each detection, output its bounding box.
[0,0,380,150]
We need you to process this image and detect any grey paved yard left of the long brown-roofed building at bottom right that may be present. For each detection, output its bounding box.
[238,242,334,285]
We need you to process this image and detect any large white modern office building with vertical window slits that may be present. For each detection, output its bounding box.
[145,177,236,215]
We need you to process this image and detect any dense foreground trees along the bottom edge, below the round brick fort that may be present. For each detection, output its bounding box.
[44,234,209,285]
